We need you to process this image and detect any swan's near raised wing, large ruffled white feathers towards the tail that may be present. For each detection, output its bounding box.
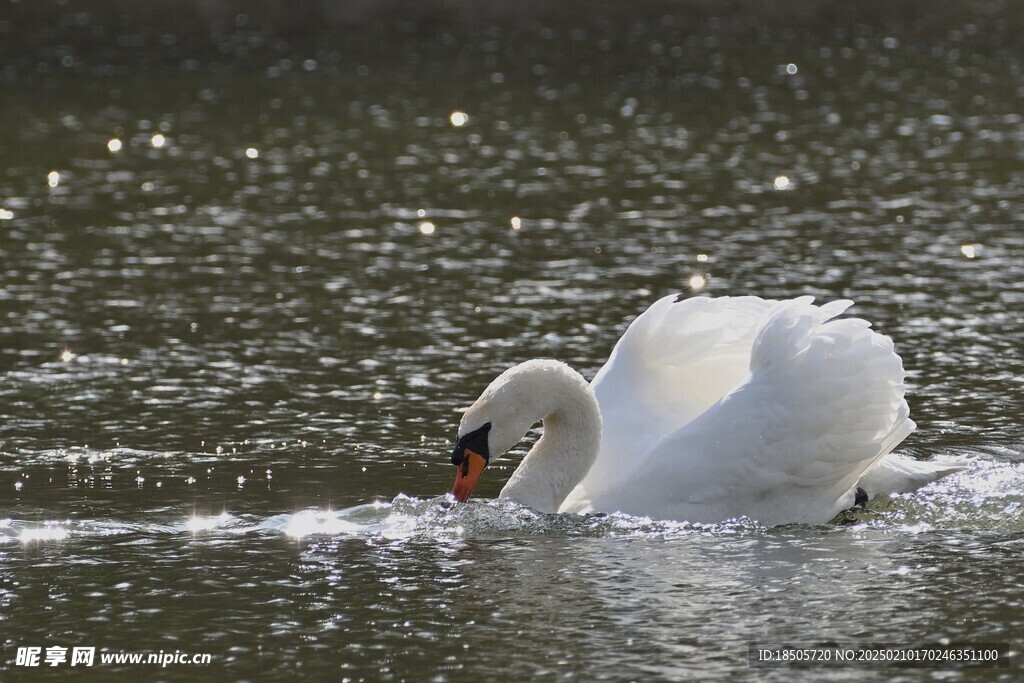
[589,298,914,524]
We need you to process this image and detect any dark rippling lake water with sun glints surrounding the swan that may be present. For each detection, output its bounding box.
[0,2,1024,681]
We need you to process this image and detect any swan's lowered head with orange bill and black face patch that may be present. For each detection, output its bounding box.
[452,360,573,503]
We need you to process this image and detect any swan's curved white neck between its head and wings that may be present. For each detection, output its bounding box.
[500,366,601,512]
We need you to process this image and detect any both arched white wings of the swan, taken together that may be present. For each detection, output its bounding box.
[563,297,914,524]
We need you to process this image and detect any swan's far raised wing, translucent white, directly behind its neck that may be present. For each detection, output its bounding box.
[585,295,777,485]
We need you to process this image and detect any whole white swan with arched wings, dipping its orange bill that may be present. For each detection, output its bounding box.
[452,296,962,524]
